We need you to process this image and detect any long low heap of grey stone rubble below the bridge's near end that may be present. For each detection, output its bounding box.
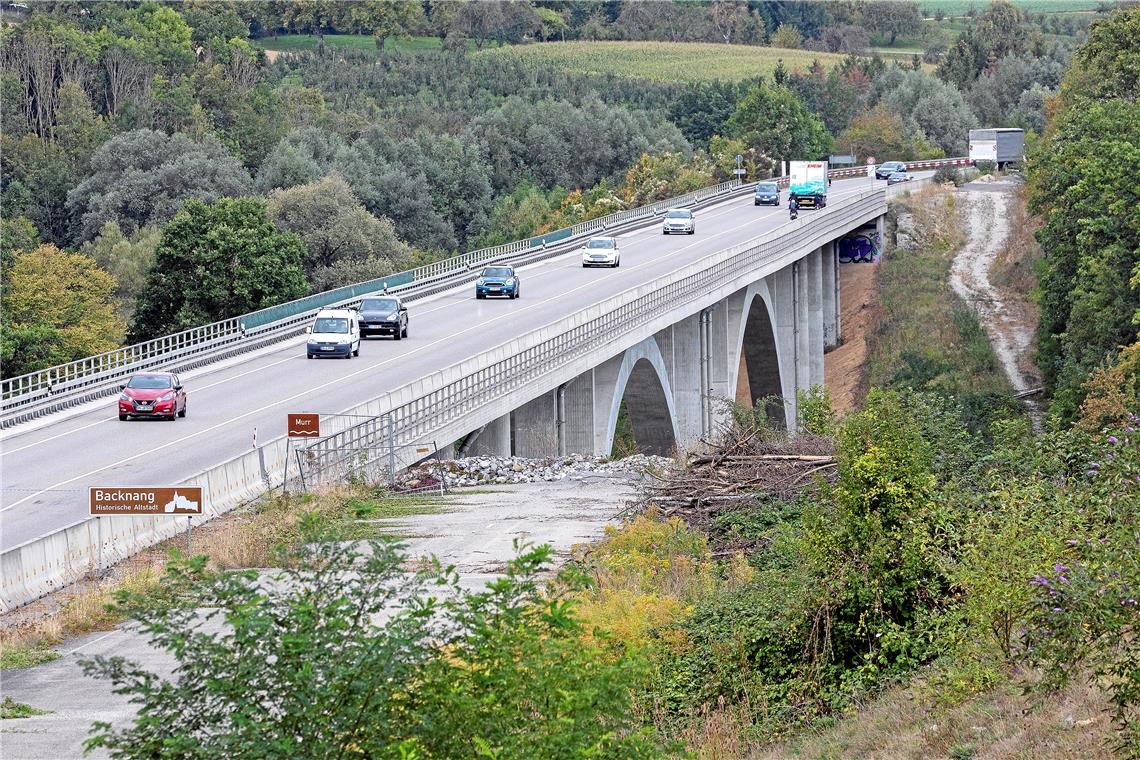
[397,453,676,490]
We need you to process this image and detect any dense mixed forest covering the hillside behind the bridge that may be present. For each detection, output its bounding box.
[0,0,1135,426]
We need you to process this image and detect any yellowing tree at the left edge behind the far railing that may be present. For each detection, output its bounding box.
[2,244,124,377]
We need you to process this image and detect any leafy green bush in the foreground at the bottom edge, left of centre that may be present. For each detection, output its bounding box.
[83,537,661,760]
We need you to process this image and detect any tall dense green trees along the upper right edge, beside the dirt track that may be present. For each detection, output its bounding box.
[1028,8,1140,423]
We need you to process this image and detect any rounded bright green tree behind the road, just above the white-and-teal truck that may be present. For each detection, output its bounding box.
[727,84,831,161]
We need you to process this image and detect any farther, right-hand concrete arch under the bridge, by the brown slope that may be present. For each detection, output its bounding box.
[733,280,795,427]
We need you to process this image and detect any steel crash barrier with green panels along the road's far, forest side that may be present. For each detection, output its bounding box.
[0,158,969,427]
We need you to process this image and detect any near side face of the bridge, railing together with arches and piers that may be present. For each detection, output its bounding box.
[302,181,888,482]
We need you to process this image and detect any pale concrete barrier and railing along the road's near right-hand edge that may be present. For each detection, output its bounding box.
[0,169,916,610]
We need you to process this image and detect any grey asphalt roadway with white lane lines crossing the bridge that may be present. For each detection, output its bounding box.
[0,172,912,550]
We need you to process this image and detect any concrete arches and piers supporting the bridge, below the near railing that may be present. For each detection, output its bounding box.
[448,216,857,457]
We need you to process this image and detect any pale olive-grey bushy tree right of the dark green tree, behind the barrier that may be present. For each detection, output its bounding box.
[268,174,413,292]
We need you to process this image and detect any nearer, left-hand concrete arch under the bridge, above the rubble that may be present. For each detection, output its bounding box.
[603,337,679,456]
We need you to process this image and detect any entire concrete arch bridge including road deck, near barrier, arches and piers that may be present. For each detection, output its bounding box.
[0,172,916,608]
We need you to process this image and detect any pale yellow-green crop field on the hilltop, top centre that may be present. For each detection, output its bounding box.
[478,42,857,82]
